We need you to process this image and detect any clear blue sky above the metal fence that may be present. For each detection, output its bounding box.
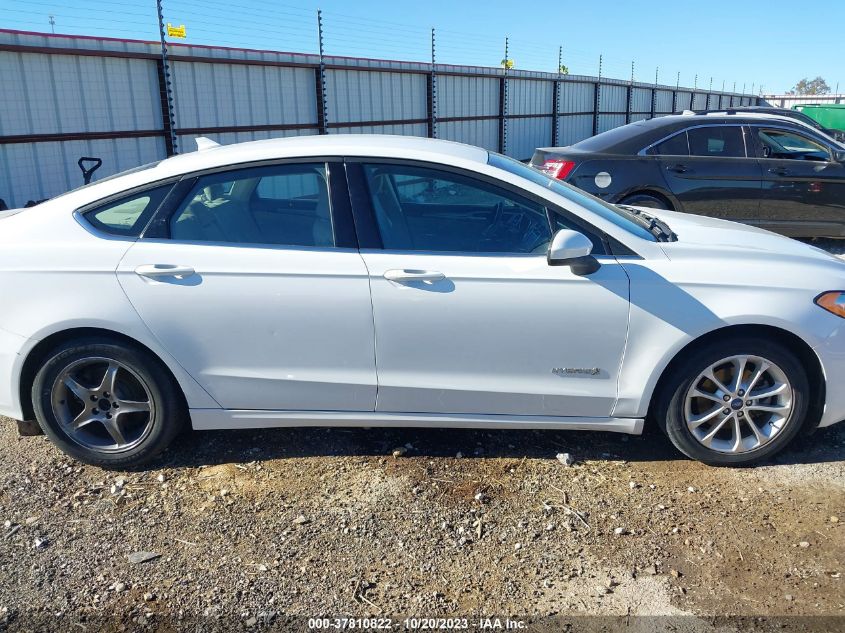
[0,0,845,94]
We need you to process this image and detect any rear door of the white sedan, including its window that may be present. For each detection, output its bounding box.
[118,162,376,411]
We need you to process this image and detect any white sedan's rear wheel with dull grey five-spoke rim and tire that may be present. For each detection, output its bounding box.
[32,338,187,469]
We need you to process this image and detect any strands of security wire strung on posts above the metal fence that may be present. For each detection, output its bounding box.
[0,0,784,94]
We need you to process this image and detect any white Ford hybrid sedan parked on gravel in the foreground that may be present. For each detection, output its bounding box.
[0,135,845,468]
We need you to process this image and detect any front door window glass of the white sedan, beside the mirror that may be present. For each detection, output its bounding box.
[364,165,551,254]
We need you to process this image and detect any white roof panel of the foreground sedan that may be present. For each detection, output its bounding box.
[156,134,488,176]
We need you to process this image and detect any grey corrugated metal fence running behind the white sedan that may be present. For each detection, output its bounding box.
[0,30,757,206]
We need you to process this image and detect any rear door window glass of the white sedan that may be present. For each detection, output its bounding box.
[170,163,335,247]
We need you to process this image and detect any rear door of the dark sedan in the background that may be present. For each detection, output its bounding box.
[648,125,762,221]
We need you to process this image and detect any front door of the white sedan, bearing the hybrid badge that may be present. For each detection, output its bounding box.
[348,163,629,417]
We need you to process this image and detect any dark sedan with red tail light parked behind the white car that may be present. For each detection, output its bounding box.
[531,113,845,237]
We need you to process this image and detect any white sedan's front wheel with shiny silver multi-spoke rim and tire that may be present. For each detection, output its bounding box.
[654,337,810,466]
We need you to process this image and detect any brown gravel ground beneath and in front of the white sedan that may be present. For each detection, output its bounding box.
[0,242,845,631]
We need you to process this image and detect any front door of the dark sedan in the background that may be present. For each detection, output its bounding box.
[751,125,845,237]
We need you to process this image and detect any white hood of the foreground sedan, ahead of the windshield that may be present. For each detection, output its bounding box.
[628,209,845,267]
